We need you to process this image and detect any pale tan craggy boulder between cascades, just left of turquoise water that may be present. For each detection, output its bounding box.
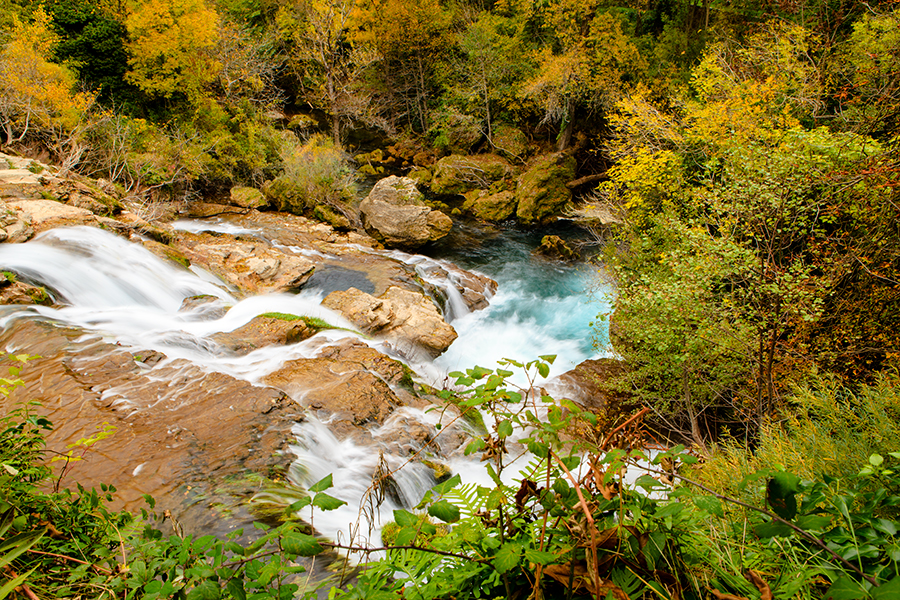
[322,286,456,358]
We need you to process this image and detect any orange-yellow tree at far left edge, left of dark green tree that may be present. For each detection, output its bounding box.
[0,8,94,144]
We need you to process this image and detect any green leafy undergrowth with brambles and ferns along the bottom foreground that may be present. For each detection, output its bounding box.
[0,356,900,600]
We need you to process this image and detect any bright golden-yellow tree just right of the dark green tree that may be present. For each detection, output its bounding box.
[125,0,221,105]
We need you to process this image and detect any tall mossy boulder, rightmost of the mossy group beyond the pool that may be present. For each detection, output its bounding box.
[516,153,575,225]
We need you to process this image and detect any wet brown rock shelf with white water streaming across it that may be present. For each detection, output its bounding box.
[0,155,616,529]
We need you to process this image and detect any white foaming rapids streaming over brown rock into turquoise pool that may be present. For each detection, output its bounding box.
[0,222,603,544]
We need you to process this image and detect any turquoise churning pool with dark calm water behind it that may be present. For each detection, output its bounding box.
[435,224,609,383]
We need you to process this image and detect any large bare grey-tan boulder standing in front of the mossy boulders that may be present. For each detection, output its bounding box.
[359,175,453,248]
